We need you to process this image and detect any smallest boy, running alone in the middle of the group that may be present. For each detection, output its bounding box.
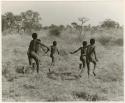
[49,41,59,72]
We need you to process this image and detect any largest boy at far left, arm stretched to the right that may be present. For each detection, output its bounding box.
[27,33,49,73]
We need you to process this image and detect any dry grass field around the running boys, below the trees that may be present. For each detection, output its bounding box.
[2,29,124,101]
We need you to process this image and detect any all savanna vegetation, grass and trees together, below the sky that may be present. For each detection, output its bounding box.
[2,10,124,101]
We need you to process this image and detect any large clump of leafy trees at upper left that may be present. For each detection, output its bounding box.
[2,10,42,32]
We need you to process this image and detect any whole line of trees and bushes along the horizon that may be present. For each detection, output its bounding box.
[2,10,120,37]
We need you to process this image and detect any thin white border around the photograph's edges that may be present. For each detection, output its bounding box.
[0,0,125,103]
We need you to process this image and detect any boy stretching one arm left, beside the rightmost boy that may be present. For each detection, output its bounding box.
[71,41,87,77]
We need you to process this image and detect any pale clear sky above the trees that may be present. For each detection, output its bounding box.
[2,0,123,26]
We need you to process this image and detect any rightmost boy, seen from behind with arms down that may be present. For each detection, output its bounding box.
[86,39,98,77]
